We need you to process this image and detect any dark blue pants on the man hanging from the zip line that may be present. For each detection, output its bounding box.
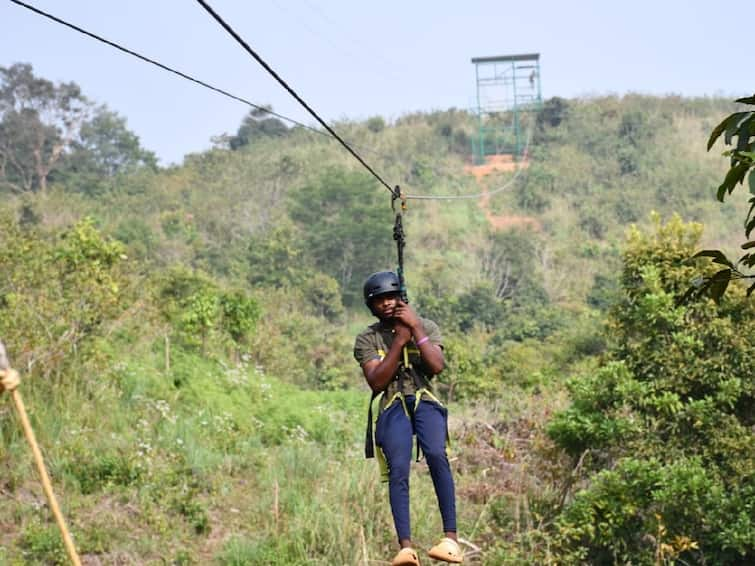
[375,395,456,541]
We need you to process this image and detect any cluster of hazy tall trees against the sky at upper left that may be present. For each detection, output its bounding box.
[0,63,157,197]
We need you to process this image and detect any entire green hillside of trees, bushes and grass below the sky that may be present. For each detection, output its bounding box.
[0,63,755,565]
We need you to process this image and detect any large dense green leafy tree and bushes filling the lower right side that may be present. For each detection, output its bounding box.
[549,218,755,564]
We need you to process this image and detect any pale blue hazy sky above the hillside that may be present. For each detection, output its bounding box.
[0,0,755,164]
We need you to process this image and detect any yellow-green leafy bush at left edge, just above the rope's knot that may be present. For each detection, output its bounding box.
[0,217,129,382]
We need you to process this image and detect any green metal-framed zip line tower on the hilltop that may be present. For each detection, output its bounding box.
[472,53,543,165]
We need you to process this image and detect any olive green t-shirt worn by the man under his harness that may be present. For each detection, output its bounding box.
[354,317,443,408]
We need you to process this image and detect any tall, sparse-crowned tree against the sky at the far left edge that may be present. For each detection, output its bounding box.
[0,63,91,193]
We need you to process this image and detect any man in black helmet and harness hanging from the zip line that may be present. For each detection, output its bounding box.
[354,271,462,566]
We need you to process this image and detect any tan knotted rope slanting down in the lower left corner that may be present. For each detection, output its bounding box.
[0,342,81,566]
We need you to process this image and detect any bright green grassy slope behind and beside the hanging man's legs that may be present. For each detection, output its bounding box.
[0,336,568,565]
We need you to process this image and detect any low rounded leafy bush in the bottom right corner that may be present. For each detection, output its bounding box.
[557,457,755,564]
